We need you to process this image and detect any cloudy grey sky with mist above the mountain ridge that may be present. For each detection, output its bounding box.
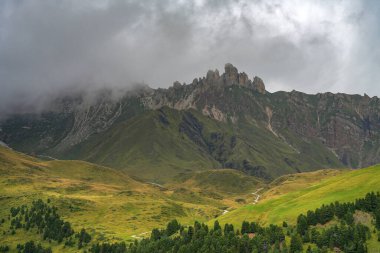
[0,0,380,112]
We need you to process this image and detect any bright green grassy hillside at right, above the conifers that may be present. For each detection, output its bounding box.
[212,165,380,225]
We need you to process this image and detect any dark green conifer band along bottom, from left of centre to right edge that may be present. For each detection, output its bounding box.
[90,192,380,253]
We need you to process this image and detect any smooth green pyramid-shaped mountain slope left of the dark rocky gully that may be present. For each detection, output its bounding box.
[59,107,218,183]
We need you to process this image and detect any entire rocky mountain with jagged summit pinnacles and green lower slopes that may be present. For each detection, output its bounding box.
[0,64,380,183]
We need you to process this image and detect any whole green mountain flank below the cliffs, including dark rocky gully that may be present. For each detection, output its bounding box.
[56,107,342,183]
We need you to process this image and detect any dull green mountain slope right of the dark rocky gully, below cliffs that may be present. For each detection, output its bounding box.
[227,119,343,179]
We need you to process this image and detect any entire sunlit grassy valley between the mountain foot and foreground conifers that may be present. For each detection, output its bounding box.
[0,144,380,252]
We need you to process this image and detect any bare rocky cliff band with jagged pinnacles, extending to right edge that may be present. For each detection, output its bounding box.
[143,64,380,168]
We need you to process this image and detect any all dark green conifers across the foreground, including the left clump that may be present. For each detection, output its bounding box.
[0,192,380,253]
